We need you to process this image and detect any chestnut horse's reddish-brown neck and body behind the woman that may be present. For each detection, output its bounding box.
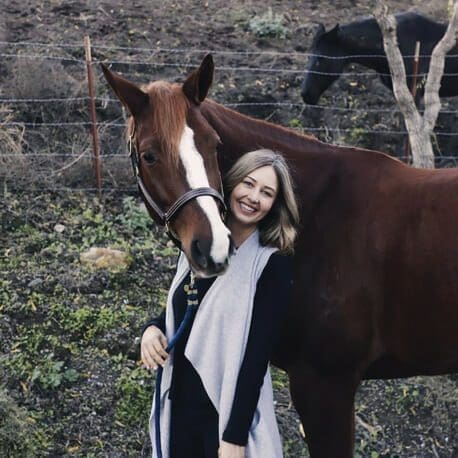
[104,58,458,458]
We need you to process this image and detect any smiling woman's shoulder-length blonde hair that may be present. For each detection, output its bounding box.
[224,149,299,253]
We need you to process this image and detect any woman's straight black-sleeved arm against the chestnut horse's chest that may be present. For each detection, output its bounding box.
[223,253,292,445]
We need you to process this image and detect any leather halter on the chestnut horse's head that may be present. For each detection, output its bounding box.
[127,126,226,249]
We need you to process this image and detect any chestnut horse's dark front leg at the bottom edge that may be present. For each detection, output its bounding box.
[288,366,359,458]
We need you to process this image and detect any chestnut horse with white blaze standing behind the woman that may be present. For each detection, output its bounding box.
[104,55,458,458]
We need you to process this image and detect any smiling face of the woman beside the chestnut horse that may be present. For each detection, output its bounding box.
[229,165,278,227]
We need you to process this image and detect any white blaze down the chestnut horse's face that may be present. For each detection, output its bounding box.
[180,125,229,263]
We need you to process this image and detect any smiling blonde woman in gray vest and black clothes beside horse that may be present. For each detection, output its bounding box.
[141,149,299,458]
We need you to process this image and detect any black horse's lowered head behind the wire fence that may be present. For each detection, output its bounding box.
[301,24,345,105]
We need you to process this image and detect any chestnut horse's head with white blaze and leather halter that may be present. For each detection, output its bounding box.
[102,55,233,277]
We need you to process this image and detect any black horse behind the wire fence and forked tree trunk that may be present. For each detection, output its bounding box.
[301,12,458,105]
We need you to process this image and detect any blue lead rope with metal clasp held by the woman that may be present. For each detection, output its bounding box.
[154,271,199,458]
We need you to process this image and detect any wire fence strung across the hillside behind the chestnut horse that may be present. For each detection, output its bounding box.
[0,37,458,192]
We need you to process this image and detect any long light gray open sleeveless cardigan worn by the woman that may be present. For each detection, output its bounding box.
[150,231,283,458]
